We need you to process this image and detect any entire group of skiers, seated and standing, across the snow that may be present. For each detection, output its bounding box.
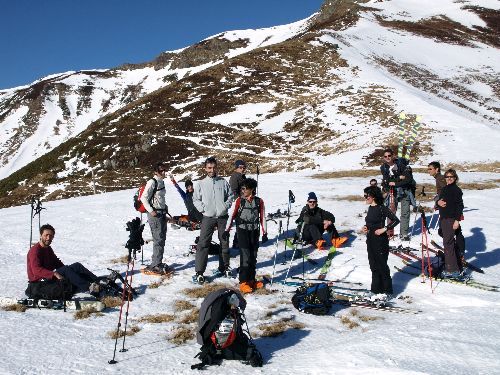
[27,149,465,302]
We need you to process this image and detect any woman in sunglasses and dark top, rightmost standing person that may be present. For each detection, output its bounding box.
[437,169,465,279]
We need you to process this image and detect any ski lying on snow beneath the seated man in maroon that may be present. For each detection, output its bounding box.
[0,297,106,311]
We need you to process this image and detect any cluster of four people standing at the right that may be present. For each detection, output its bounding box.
[362,149,465,296]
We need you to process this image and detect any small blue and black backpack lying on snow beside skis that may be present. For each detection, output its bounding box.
[292,283,332,315]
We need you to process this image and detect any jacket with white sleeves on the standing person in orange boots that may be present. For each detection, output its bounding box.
[226,197,267,234]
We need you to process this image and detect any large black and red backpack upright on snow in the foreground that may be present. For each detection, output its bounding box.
[191,288,263,370]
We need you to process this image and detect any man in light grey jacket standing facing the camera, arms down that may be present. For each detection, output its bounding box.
[193,157,232,284]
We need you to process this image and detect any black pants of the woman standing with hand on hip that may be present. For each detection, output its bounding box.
[366,230,392,294]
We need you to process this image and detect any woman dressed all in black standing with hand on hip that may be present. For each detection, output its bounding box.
[362,186,399,298]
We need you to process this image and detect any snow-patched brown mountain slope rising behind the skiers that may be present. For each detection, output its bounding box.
[0,0,500,206]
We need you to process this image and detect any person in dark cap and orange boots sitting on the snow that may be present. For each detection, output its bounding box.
[295,192,347,249]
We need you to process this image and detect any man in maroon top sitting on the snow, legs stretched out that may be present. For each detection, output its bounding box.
[26,224,99,296]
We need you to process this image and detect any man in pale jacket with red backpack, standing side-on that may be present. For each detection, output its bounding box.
[141,163,169,275]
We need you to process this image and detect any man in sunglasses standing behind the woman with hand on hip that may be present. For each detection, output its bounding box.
[380,149,417,241]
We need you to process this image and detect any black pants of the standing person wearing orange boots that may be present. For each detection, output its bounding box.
[236,228,259,283]
